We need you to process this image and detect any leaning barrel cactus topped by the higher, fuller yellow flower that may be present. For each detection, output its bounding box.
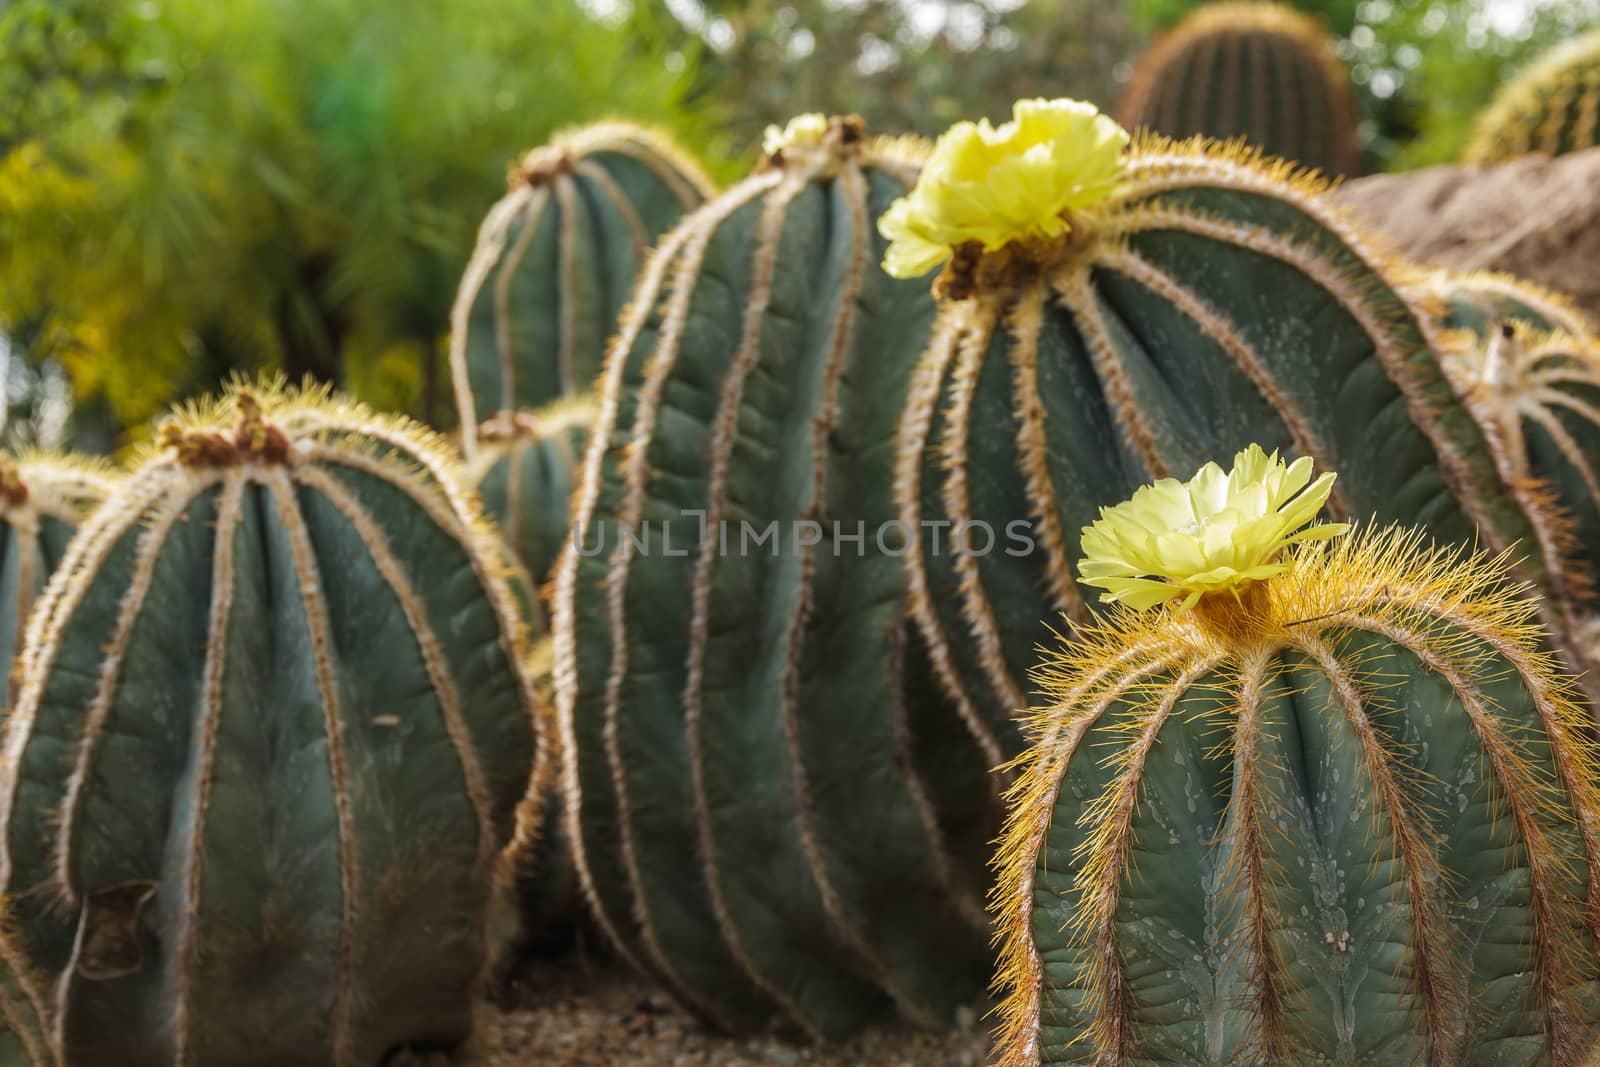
[883,101,1558,758]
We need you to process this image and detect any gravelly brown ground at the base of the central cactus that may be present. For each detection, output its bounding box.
[461,953,989,1067]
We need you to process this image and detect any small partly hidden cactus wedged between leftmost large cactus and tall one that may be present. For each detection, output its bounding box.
[467,400,594,584]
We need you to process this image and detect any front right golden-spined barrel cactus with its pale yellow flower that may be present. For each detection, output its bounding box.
[994,450,1600,1067]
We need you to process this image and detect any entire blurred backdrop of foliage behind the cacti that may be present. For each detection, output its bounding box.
[0,0,1600,451]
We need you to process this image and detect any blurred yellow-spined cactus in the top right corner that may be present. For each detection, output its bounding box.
[1464,30,1600,163]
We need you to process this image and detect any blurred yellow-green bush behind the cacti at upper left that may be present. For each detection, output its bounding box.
[0,0,709,441]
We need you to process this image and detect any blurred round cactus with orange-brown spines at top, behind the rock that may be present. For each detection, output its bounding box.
[1117,3,1362,174]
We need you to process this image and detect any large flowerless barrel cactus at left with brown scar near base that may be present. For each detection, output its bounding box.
[0,389,538,1067]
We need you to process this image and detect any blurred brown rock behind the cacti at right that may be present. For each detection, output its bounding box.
[1334,149,1600,320]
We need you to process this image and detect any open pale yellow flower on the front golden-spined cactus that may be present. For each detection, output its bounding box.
[1078,445,1350,611]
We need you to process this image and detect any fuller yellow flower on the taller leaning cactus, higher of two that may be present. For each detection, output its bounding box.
[878,99,1128,278]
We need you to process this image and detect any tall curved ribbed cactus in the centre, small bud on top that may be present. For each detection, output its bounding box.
[554,115,994,1038]
